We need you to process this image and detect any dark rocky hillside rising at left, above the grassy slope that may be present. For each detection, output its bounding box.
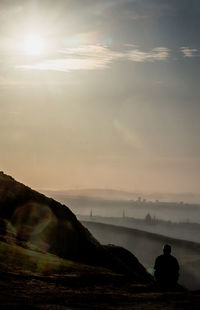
[0,172,152,283]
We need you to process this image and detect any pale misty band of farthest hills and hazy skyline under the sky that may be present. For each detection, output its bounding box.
[41,191,200,223]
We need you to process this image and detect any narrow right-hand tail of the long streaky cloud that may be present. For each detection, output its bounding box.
[128,47,170,62]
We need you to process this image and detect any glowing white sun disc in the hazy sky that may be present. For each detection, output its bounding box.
[23,35,45,55]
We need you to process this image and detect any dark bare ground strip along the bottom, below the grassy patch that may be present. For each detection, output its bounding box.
[0,273,200,310]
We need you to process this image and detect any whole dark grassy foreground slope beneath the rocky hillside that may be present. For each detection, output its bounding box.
[0,241,200,310]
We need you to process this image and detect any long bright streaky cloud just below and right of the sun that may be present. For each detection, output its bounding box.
[17,45,170,72]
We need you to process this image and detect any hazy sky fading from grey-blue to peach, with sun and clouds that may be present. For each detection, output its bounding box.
[0,0,200,194]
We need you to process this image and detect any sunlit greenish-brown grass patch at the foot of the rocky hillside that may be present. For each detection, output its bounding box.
[0,237,112,275]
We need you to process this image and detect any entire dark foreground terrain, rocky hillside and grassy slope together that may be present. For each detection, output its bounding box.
[0,172,200,310]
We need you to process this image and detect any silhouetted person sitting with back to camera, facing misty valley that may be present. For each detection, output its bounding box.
[154,244,179,288]
